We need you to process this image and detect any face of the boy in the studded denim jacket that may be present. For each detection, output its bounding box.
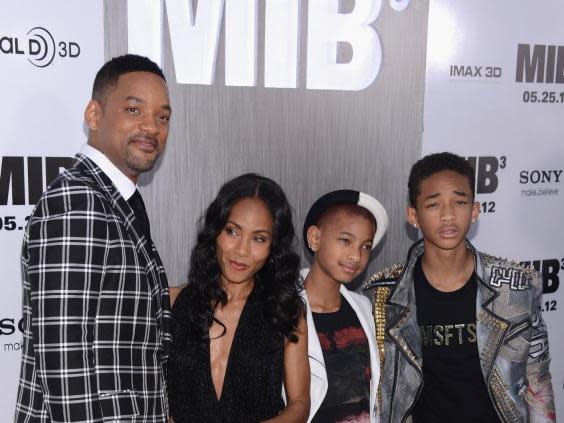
[407,170,480,250]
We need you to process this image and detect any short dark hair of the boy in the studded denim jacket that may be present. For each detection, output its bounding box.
[407,152,476,207]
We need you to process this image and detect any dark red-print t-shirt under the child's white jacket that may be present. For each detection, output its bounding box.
[312,295,371,423]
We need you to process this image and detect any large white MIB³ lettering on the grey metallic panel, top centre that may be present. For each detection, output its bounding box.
[127,0,410,91]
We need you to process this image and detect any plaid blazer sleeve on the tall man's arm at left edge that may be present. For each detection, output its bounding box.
[27,181,108,422]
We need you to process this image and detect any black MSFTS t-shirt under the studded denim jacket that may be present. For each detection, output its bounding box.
[413,257,500,423]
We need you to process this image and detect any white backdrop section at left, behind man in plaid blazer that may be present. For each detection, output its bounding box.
[0,0,104,422]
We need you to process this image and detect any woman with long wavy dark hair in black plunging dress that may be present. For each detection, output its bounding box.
[168,174,309,423]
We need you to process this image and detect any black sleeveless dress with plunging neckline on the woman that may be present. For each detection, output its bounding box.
[168,286,284,423]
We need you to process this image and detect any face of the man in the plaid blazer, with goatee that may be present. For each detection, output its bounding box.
[85,72,171,182]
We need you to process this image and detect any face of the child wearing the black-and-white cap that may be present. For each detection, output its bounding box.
[307,211,376,283]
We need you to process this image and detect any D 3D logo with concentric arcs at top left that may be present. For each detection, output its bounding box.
[0,26,80,68]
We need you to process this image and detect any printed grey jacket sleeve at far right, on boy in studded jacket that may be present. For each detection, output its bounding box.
[525,272,556,423]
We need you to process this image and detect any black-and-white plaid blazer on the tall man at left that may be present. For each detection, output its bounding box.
[15,154,171,423]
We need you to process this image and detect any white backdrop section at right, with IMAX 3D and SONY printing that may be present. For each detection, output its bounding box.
[423,0,564,418]
